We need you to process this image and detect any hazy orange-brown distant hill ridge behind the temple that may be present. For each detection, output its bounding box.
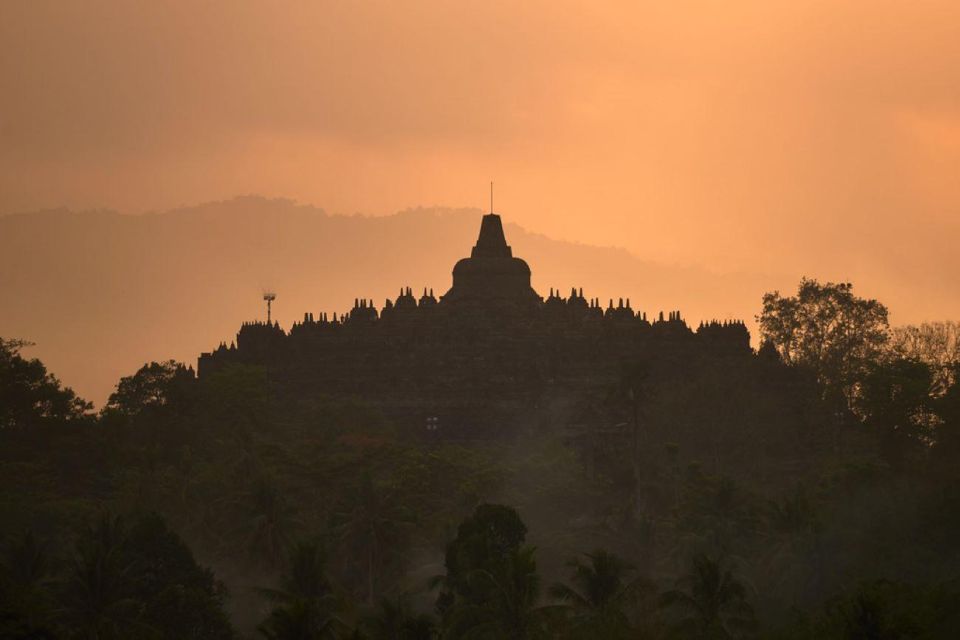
[0,197,797,405]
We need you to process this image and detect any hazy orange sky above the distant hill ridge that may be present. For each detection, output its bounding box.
[0,0,960,318]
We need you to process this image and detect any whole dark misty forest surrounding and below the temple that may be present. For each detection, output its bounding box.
[0,280,960,640]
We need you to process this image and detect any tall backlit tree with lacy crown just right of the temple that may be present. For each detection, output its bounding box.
[757,278,889,397]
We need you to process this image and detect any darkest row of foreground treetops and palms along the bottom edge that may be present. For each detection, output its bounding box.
[7,504,960,640]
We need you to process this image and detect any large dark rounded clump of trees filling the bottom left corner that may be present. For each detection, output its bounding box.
[0,513,235,640]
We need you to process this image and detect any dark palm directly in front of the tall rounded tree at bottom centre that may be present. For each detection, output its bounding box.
[445,546,548,640]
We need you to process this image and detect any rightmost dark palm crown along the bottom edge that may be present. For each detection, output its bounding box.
[660,554,754,640]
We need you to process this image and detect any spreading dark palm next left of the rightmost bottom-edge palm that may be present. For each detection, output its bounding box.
[550,550,648,638]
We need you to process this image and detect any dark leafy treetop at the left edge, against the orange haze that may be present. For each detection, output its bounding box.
[0,338,93,430]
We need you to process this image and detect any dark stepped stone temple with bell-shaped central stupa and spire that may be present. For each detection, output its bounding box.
[198,213,752,433]
